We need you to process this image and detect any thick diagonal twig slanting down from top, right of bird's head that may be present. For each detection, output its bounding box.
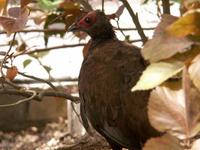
[121,0,148,44]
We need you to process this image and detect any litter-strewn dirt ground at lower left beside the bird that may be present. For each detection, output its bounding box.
[0,119,110,150]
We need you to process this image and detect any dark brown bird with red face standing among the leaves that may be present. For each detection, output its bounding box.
[69,10,159,150]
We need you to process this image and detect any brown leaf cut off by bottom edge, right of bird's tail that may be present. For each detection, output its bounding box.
[143,134,184,150]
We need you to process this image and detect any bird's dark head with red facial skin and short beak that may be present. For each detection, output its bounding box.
[68,10,115,39]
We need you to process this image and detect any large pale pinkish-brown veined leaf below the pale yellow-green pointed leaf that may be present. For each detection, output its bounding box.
[148,87,200,139]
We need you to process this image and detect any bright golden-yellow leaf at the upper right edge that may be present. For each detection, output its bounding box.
[166,9,200,37]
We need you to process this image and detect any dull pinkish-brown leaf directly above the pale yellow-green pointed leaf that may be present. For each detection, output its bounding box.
[142,15,194,62]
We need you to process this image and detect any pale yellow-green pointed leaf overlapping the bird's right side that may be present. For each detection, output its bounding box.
[132,59,184,91]
